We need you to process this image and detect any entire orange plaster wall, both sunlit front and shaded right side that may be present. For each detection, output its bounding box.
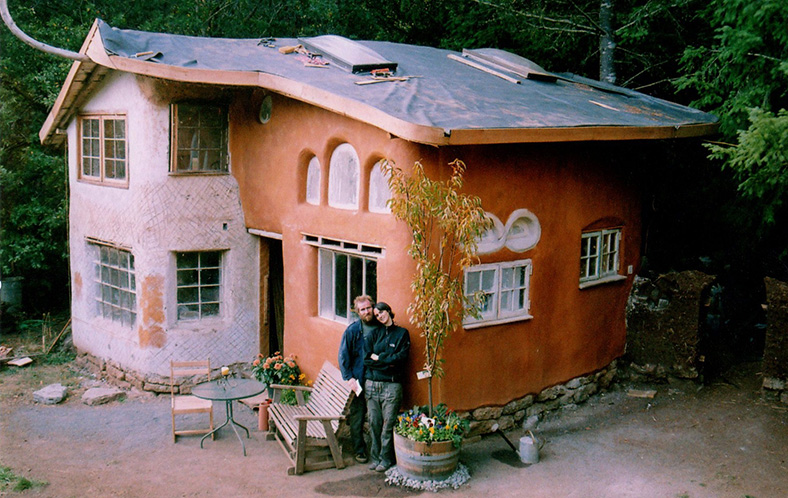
[228,88,640,409]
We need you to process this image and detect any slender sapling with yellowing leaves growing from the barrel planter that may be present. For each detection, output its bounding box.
[383,159,490,417]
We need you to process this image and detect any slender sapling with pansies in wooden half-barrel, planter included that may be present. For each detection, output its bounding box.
[383,159,490,480]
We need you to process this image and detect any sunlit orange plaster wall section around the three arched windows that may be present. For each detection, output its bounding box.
[231,92,422,378]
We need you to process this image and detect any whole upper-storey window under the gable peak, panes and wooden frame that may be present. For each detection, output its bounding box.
[79,115,128,186]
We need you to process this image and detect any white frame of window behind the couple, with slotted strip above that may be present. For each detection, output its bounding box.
[303,235,384,324]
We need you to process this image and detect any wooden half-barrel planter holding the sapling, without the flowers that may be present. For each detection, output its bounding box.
[394,432,460,481]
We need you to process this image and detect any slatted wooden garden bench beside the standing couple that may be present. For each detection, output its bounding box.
[268,362,355,475]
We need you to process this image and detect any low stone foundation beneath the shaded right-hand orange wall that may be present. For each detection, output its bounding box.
[459,360,618,438]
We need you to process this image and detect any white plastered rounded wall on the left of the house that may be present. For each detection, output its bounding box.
[68,73,259,375]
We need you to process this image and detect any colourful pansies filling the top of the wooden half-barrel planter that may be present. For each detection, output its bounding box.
[394,403,469,448]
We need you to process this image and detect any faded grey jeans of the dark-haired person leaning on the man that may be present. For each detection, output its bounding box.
[364,380,402,467]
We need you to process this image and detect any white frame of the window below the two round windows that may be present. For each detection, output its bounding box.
[463,259,533,329]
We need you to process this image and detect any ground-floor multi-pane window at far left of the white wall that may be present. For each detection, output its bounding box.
[91,244,137,327]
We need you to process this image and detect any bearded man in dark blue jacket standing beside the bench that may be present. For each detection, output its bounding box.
[339,295,380,463]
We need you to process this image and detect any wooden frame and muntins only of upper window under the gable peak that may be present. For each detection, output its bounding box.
[77,114,129,188]
